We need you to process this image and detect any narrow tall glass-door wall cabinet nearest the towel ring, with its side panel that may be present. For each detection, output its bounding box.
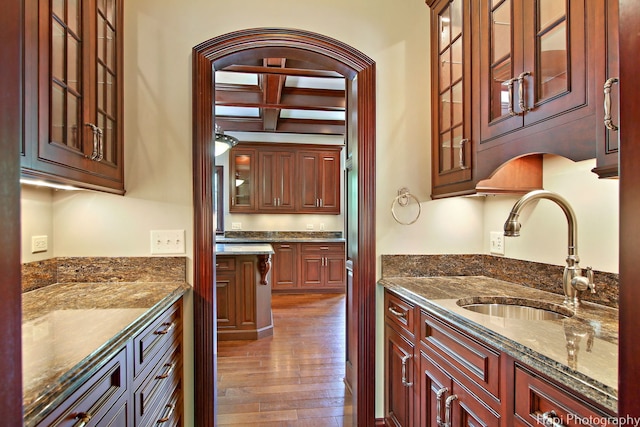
[429,0,542,198]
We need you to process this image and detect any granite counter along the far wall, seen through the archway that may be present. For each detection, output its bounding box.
[216,231,345,243]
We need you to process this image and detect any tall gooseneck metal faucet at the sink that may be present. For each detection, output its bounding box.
[504,190,596,308]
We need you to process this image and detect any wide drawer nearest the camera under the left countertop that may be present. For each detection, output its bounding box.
[38,348,127,427]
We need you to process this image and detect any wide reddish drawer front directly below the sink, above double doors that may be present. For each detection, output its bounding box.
[420,310,500,399]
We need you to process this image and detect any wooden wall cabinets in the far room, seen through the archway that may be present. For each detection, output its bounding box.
[229,144,342,214]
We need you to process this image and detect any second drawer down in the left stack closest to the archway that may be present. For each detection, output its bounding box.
[134,337,182,426]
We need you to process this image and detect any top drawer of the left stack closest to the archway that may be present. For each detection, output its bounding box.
[133,300,182,379]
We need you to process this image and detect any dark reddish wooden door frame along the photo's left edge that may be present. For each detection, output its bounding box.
[0,0,25,426]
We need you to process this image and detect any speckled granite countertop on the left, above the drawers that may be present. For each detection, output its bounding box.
[22,281,191,425]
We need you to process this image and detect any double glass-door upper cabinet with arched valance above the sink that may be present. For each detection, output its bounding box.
[473,0,606,174]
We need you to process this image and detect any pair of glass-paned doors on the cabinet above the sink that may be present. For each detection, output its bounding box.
[480,0,589,143]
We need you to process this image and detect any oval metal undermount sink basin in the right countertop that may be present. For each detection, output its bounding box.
[456,297,573,320]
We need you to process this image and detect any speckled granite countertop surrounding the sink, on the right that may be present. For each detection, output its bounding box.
[379,276,618,413]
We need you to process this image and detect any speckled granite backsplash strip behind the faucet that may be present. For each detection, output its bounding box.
[381,254,619,308]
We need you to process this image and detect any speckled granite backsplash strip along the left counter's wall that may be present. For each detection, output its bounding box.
[22,257,187,292]
